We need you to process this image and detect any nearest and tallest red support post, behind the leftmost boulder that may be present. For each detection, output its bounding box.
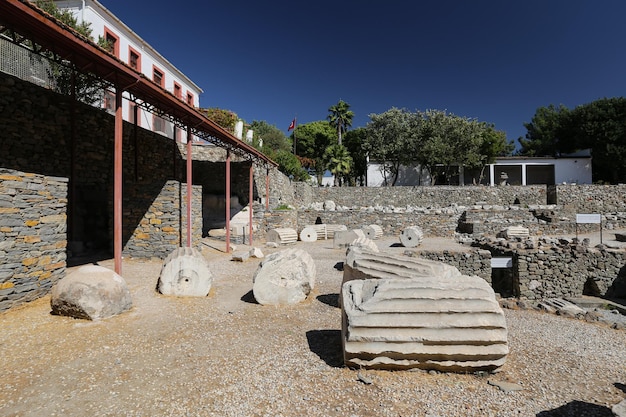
[113,86,124,275]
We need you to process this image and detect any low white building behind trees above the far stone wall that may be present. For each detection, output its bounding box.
[366,150,593,187]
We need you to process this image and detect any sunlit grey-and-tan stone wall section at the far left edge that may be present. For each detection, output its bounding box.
[0,168,67,311]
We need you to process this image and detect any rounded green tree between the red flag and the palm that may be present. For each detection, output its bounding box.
[290,121,335,184]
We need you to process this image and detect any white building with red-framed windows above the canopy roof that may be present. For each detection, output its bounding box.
[55,0,202,142]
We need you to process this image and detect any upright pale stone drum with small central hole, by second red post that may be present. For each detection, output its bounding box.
[157,247,213,297]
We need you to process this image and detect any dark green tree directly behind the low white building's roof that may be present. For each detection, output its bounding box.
[518,104,569,156]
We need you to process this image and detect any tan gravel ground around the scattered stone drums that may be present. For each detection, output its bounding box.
[0,236,626,417]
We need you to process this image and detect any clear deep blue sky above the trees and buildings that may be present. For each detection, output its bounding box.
[100,0,626,146]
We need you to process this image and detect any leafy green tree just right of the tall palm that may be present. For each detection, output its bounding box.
[363,107,423,186]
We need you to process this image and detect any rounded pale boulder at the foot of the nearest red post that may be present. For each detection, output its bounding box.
[50,265,132,320]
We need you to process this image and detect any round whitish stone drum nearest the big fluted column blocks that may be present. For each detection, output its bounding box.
[252,248,316,305]
